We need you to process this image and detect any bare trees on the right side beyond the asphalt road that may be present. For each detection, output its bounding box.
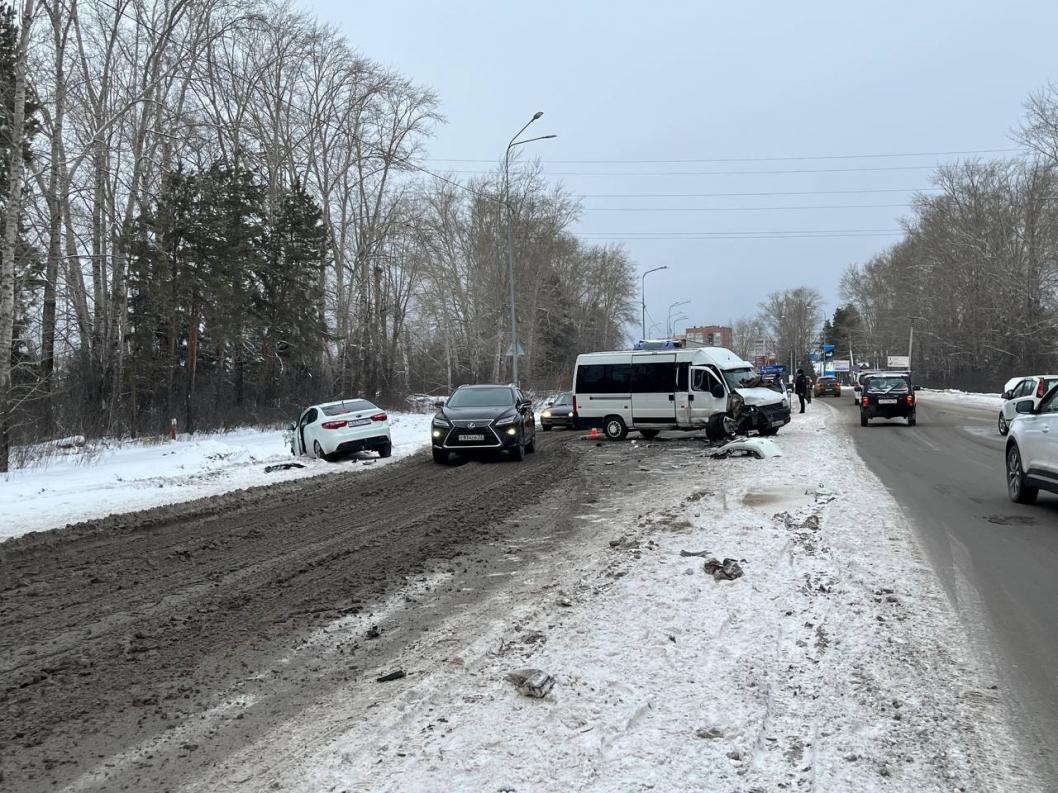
[835,87,1058,391]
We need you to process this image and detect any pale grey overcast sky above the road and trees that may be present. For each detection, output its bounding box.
[303,0,1058,335]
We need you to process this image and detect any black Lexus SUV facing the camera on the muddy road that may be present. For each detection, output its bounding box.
[431,386,536,463]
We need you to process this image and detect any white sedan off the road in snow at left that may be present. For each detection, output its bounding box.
[288,400,394,461]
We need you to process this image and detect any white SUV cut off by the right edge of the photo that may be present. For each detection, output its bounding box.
[1006,388,1058,504]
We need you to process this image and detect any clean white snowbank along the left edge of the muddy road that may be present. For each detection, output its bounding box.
[0,412,432,540]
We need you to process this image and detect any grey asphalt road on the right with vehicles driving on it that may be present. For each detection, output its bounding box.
[825,395,1058,790]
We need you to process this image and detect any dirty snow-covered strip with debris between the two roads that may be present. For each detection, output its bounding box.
[179,410,1039,793]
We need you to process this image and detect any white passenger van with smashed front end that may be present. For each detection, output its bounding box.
[573,347,790,440]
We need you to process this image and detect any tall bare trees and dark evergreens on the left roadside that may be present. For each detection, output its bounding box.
[0,0,634,471]
